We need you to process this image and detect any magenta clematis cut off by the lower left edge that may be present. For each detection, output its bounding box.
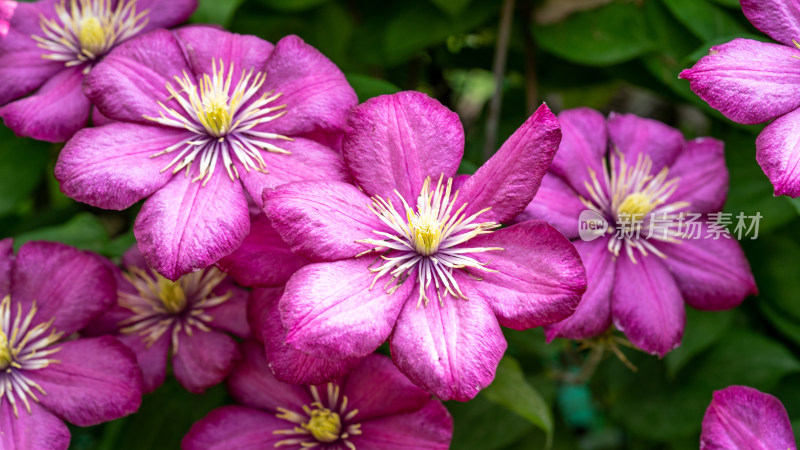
[0,239,142,450]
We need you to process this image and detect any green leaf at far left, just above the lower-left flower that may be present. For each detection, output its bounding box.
[14,212,108,253]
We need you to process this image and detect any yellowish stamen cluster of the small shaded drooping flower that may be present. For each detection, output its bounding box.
[117,267,233,353]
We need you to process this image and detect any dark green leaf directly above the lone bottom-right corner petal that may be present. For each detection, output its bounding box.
[692,329,800,390]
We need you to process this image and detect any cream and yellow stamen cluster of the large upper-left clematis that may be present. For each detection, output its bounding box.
[144,60,292,184]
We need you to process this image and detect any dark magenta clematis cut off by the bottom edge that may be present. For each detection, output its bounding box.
[181,343,453,450]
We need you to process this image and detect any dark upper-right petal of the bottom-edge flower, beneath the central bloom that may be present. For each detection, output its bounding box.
[343,355,432,421]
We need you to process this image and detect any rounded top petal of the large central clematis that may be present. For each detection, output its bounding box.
[342,91,462,200]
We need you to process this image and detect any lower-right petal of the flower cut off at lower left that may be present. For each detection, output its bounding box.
[26,336,142,427]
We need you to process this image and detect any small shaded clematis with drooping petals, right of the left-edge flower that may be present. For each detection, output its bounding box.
[87,247,250,393]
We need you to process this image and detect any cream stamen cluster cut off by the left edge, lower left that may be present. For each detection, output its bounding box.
[0,295,63,418]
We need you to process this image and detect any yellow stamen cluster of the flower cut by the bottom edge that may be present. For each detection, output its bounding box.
[272,383,361,450]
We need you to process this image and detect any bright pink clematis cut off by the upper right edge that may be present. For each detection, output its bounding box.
[680,0,800,197]
